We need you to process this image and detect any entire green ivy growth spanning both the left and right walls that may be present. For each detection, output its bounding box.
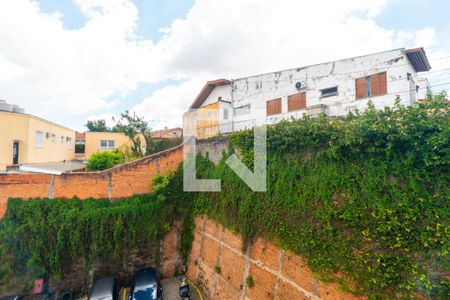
[0,101,450,299]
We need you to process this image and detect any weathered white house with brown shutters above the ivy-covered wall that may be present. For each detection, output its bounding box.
[185,48,431,134]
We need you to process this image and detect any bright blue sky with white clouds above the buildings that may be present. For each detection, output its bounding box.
[0,0,450,131]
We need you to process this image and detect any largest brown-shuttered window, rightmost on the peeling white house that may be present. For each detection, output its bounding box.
[355,72,387,99]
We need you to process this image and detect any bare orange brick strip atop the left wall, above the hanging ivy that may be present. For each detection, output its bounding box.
[0,146,183,218]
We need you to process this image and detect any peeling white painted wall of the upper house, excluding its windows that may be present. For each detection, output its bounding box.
[232,49,417,130]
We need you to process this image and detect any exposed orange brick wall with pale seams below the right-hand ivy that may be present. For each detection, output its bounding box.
[187,217,363,300]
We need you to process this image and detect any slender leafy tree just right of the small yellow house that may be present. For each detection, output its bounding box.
[112,110,155,156]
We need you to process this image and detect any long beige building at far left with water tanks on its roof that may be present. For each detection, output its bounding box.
[0,109,75,172]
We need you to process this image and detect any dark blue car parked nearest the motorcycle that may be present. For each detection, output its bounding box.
[130,268,162,300]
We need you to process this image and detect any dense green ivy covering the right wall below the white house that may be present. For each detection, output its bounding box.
[192,101,450,299]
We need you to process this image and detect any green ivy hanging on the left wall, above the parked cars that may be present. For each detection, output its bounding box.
[0,169,191,293]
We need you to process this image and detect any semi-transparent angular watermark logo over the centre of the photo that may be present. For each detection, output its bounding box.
[183,108,267,192]
